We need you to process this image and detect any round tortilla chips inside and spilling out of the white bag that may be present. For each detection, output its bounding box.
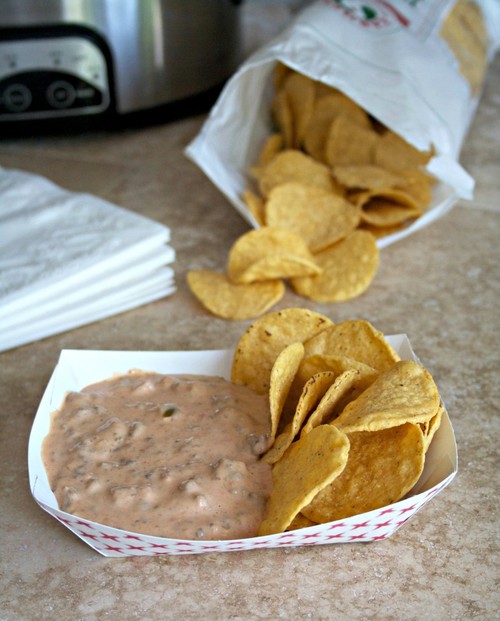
[188,64,450,319]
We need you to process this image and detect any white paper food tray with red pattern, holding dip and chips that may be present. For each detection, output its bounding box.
[28,334,457,557]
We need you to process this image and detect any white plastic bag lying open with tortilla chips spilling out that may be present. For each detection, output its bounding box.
[186,0,500,247]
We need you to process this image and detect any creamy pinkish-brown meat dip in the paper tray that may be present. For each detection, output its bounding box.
[43,371,272,539]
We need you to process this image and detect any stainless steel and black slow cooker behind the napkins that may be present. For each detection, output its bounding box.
[0,0,241,136]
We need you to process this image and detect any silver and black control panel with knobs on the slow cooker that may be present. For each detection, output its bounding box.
[0,36,110,121]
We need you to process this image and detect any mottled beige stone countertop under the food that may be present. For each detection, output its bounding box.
[0,6,500,621]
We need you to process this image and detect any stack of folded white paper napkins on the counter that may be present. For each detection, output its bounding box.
[0,167,175,351]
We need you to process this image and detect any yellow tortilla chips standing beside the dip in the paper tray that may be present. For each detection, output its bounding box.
[231,308,444,535]
